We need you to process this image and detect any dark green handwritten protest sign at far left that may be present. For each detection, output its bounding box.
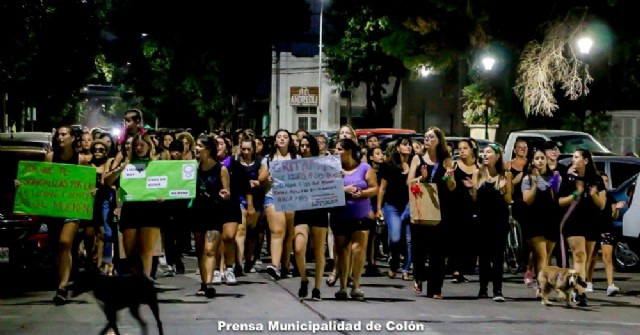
[13,161,96,220]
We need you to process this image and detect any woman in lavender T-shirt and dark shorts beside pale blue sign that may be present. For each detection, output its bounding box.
[331,139,378,300]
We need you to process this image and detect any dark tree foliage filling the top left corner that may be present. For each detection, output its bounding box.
[0,0,104,129]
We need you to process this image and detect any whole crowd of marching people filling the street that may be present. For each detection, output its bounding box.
[32,109,619,306]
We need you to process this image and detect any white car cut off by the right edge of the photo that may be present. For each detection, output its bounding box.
[609,173,640,271]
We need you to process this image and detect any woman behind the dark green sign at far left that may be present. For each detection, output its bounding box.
[44,125,89,306]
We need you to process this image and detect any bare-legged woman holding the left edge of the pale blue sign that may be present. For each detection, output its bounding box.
[258,129,299,280]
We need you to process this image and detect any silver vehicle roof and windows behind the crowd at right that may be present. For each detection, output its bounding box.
[504,129,613,162]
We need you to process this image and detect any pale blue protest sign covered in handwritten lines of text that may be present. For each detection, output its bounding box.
[269,156,344,211]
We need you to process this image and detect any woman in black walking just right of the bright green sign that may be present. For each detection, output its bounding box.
[189,135,232,298]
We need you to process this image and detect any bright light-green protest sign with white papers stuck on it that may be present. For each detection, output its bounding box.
[120,160,198,201]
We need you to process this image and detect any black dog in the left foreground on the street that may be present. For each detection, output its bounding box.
[93,273,164,335]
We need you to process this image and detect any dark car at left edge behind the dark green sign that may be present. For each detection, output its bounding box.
[0,132,52,273]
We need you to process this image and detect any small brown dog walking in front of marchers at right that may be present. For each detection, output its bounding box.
[538,266,584,308]
